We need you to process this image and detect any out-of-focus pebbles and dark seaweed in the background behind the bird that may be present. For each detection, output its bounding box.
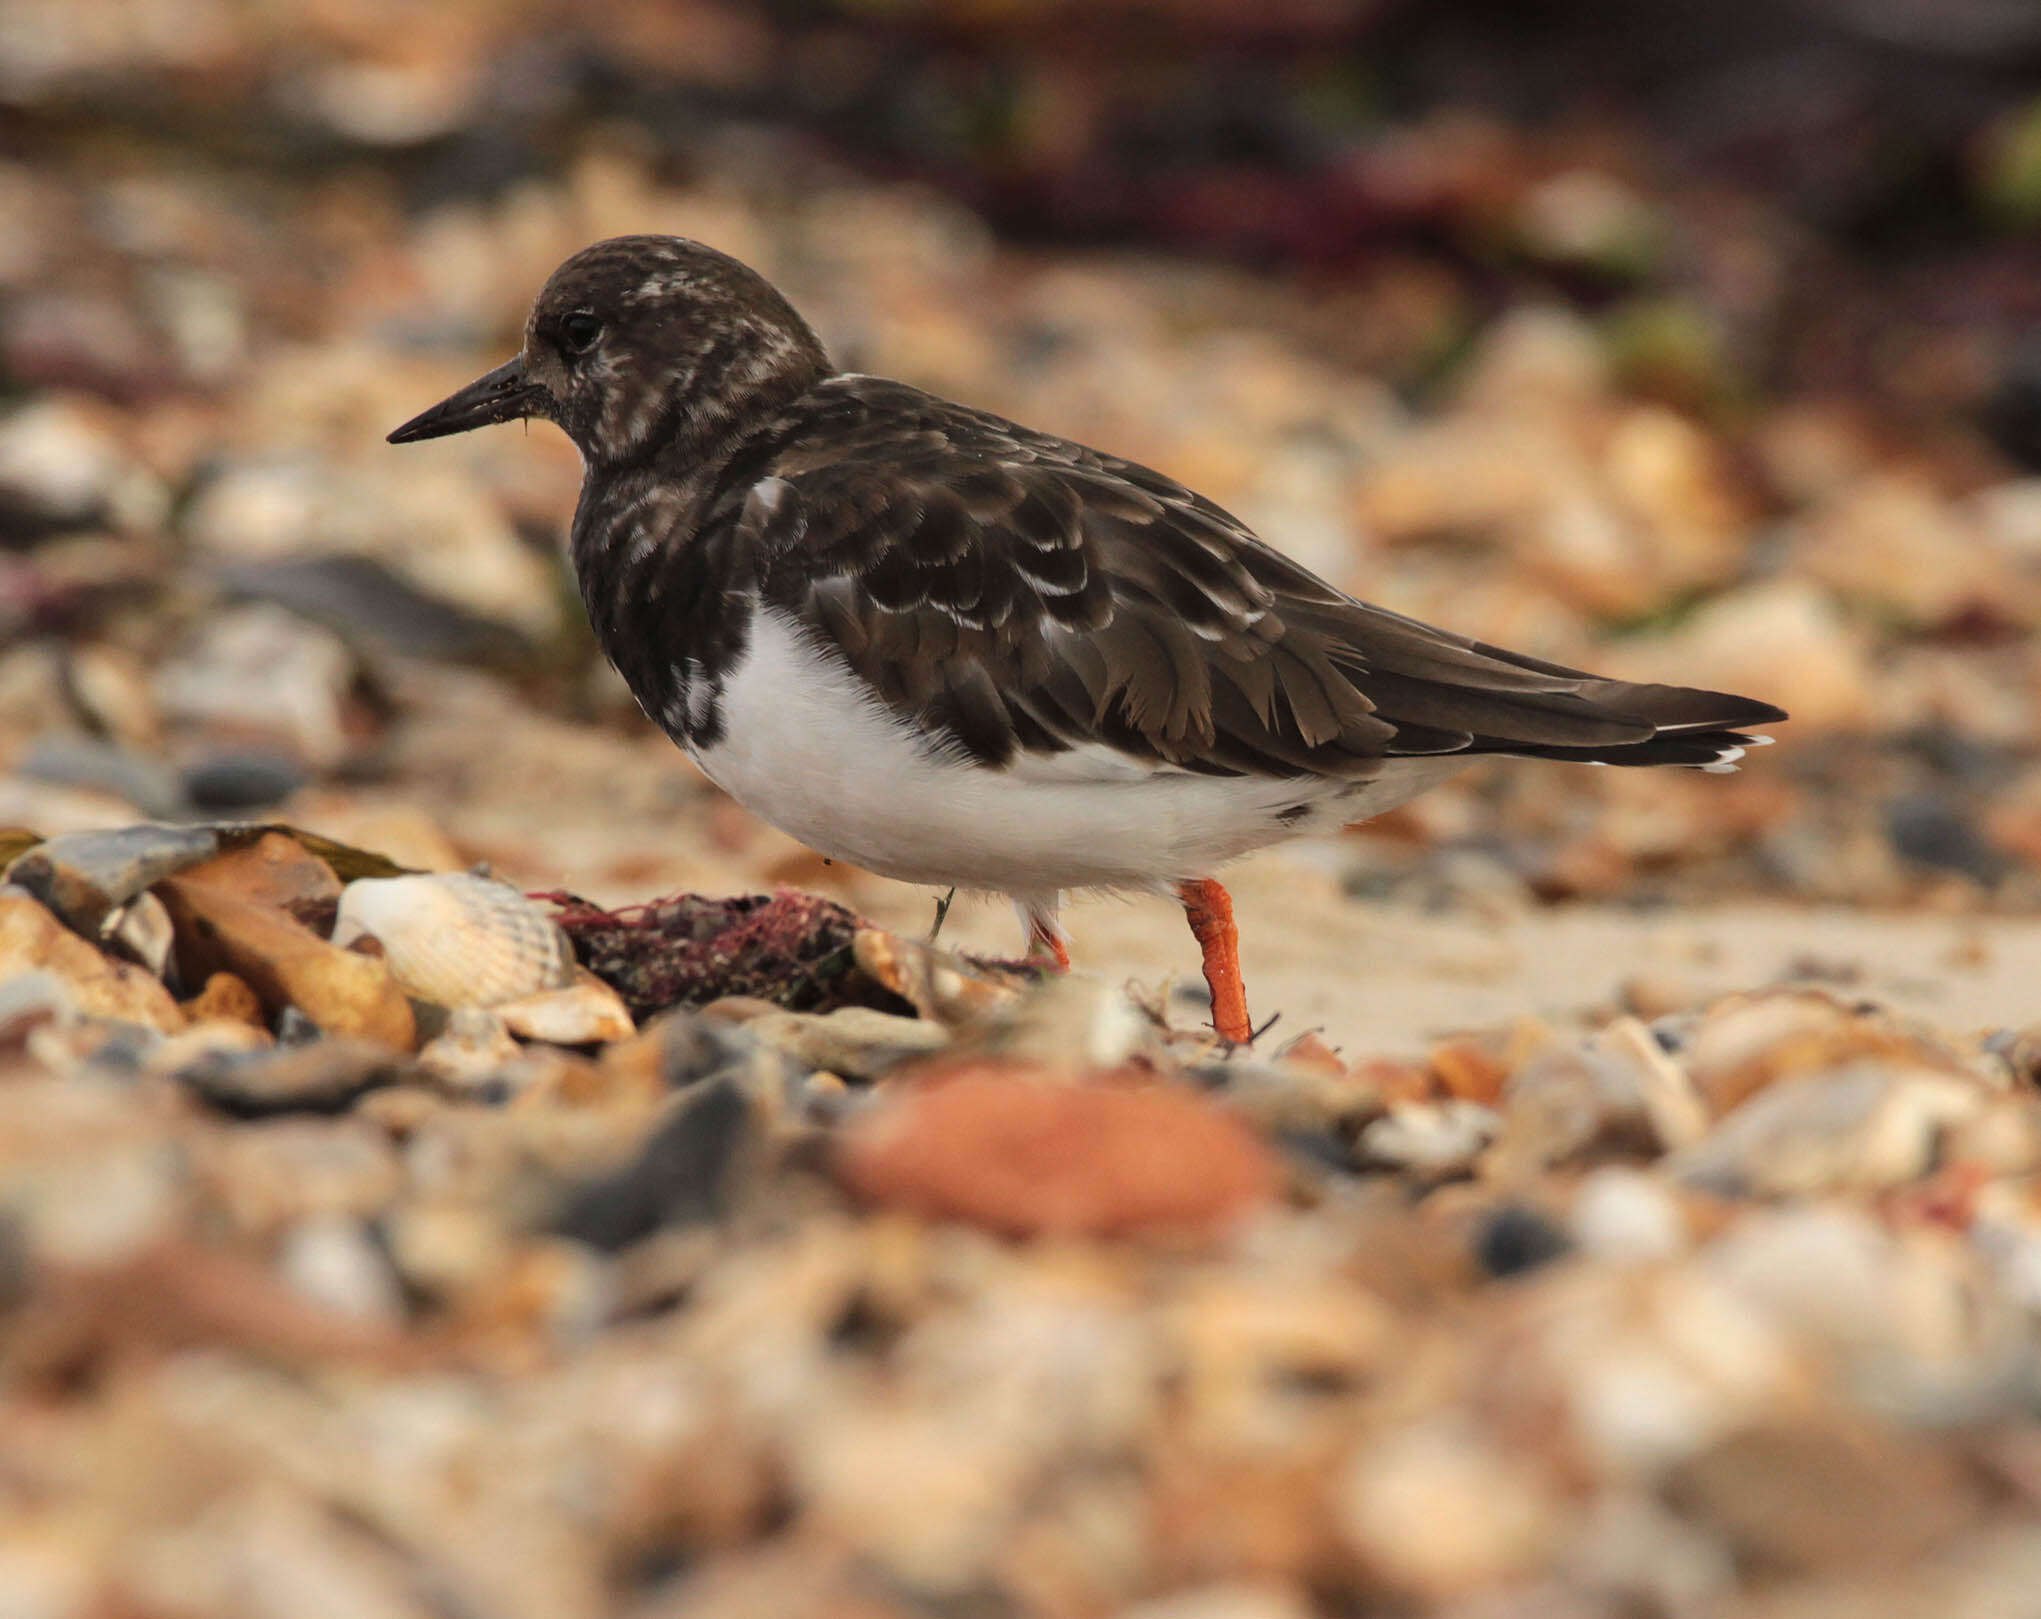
[0,0,2041,911]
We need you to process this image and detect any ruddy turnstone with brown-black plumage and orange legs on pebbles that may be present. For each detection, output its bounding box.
[390,237,1784,1041]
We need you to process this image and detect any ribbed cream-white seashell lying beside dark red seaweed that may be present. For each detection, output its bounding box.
[333,872,574,1007]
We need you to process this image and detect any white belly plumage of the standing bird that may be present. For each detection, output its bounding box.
[694,608,1465,898]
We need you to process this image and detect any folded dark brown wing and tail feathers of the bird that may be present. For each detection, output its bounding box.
[733,378,1778,778]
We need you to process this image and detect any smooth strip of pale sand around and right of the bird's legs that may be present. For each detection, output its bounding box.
[824,865,2041,1053]
